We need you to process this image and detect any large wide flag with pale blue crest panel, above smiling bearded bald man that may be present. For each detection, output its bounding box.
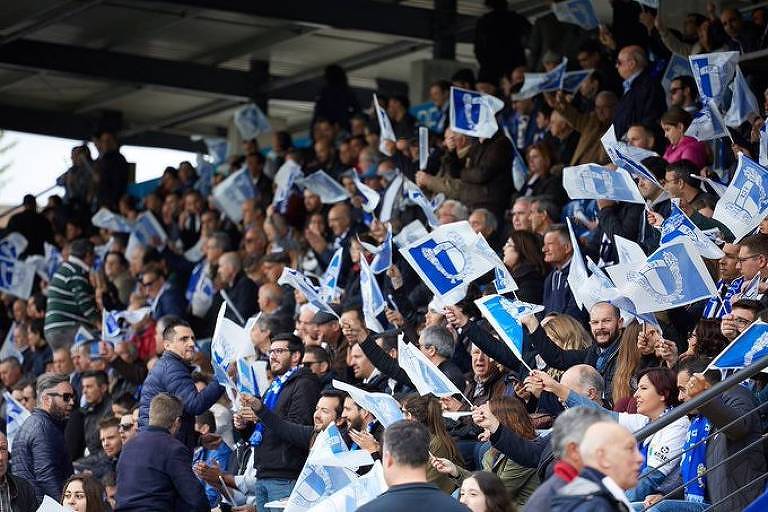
[606,241,717,313]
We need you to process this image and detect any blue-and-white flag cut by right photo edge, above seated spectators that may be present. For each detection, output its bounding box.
[712,153,768,242]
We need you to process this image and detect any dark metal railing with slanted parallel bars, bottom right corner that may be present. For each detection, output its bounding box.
[635,356,768,510]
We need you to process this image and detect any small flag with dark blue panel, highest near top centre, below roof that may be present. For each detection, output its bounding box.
[450,87,504,139]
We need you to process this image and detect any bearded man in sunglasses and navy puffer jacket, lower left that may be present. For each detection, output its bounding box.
[12,373,75,499]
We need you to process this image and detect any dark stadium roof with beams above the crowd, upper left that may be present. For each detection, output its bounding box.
[0,0,547,149]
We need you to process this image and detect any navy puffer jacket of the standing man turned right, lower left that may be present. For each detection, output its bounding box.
[139,350,224,450]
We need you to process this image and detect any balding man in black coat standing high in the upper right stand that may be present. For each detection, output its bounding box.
[613,45,667,138]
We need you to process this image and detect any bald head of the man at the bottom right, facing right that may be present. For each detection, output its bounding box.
[579,421,643,490]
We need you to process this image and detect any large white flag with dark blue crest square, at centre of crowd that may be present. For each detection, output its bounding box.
[400,221,494,304]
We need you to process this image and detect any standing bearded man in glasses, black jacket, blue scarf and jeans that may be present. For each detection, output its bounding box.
[235,333,320,510]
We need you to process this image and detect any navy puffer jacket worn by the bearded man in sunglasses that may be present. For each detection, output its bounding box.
[11,409,73,499]
